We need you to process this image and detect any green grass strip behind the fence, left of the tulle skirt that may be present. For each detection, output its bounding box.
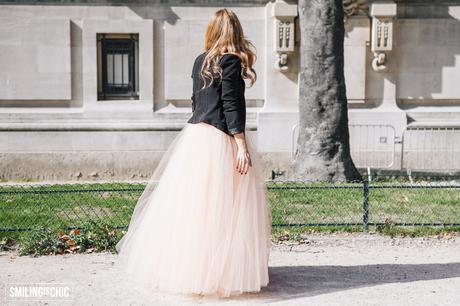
[0,183,144,229]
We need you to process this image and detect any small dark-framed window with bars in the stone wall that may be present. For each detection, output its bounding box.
[97,34,139,100]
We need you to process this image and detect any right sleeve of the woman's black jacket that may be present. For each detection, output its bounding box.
[221,54,246,135]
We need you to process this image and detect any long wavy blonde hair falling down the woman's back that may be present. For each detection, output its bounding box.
[200,8,257,88]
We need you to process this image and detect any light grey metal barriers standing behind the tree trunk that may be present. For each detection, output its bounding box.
[291,123,460,172]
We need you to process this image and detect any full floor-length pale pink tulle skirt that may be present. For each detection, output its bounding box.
[117,122,271,297]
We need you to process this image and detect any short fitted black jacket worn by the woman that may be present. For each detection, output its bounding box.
[187,52,246,135]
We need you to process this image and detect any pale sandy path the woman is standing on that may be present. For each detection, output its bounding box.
[0,234,460,306]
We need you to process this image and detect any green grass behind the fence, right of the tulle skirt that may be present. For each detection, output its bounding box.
[268,182,460,225]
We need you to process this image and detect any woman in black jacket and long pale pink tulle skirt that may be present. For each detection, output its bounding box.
[117,9,271,297]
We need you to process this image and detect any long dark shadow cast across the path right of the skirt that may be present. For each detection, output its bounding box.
[235,262,460,302]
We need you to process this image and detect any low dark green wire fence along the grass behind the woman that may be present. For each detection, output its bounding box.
[0,177,460,231]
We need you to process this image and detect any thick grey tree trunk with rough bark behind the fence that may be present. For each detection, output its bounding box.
[288,0,361,181]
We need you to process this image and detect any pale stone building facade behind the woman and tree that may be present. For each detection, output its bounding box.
[0,0,460,180]
